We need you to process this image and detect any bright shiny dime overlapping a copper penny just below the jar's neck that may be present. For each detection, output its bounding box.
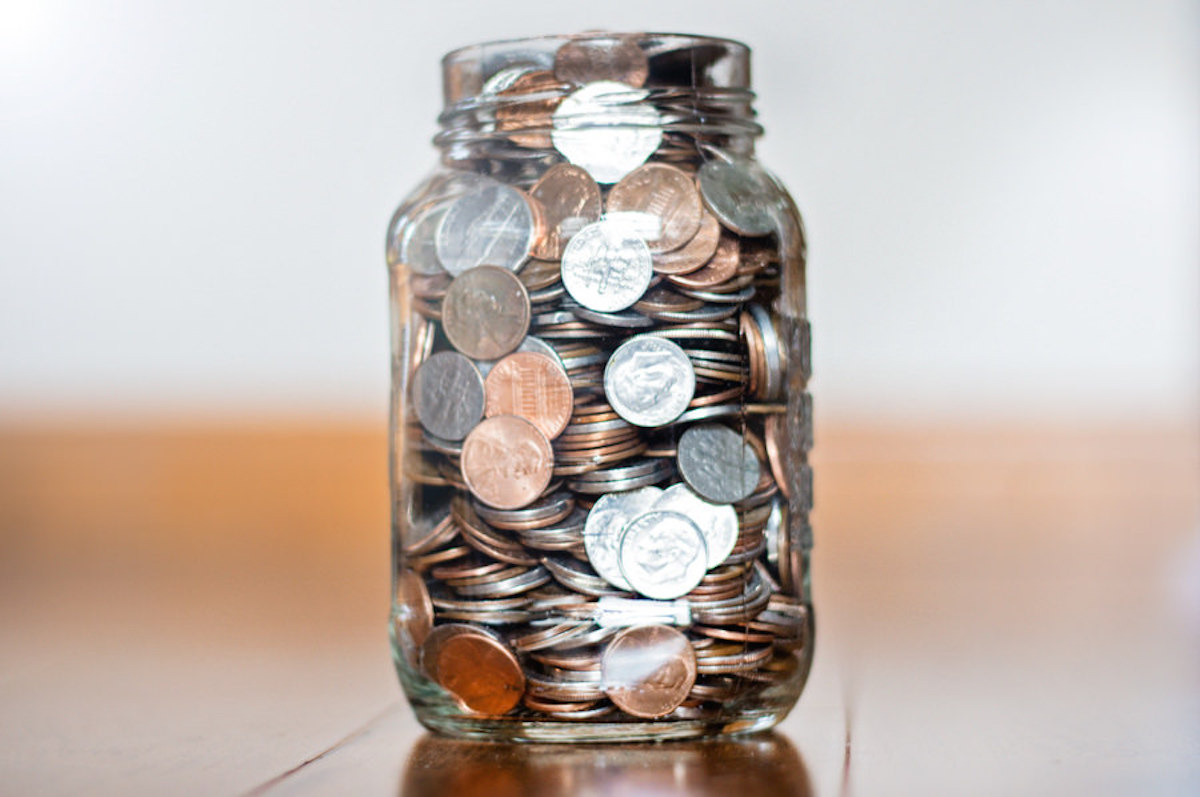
[563,221,654,313]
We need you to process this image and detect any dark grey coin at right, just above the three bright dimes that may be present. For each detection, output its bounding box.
[677,424,761,504]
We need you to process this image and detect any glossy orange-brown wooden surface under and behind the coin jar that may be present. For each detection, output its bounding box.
[0,420,1200,797]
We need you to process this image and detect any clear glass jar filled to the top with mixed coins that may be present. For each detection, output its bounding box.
[388,34,814,741]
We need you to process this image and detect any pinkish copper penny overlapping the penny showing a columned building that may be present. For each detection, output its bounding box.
[462,415,554,509]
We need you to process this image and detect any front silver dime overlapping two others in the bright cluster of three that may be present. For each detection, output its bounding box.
[617,511,708,600]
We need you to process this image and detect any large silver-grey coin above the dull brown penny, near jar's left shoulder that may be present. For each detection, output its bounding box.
[437,185,536,276]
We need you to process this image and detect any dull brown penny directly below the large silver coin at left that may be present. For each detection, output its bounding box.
[442,265,530,360]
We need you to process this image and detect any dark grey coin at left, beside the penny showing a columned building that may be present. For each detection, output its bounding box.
[413,352,485,441]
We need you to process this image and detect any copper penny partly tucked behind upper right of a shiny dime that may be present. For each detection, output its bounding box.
[607,163,703,254]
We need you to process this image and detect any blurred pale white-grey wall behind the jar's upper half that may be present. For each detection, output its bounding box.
[0,0,1200,418]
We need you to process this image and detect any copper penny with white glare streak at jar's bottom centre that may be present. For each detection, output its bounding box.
[600,625,696,719]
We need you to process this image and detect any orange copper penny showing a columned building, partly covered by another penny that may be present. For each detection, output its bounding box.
[484,352,575,439]
